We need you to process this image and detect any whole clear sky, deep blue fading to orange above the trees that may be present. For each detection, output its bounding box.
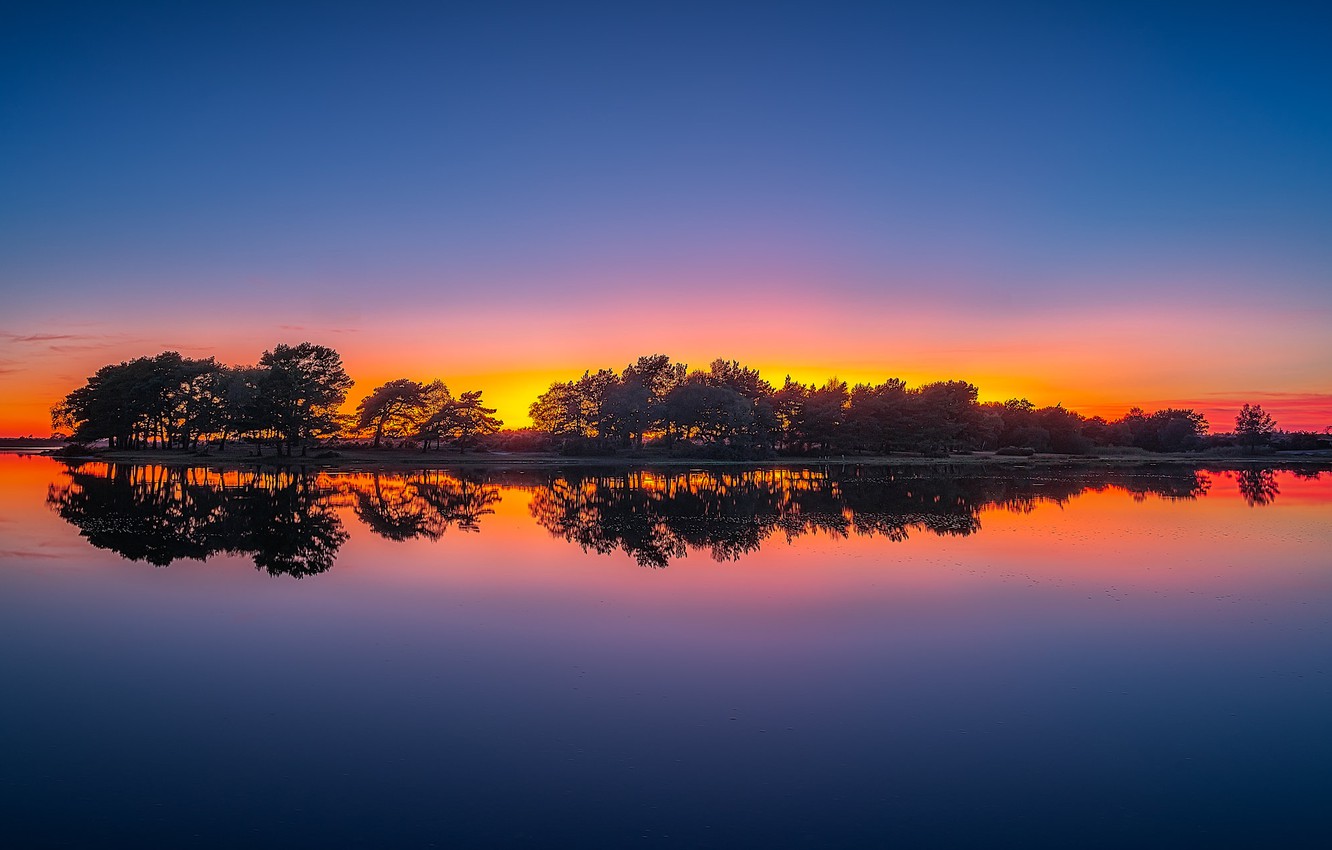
[0,1,1332,434]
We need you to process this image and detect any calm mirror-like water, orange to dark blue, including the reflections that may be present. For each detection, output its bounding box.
[0,454,1332,847]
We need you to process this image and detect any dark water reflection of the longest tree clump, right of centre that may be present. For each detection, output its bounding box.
[530,466,1211,568]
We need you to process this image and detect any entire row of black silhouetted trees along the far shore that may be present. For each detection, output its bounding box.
[52,342,1319,460]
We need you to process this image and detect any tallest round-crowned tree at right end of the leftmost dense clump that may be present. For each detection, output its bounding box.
[257,342,353,454]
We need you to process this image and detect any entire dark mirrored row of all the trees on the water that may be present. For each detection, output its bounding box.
[47,462,1320,578]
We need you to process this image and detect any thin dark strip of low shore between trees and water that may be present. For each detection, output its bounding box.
[20,448,1332,472]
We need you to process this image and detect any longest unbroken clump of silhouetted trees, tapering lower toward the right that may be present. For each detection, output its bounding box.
[530,354,1225,458]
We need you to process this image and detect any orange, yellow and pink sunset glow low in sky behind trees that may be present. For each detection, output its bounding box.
[0,296,1332,436]
